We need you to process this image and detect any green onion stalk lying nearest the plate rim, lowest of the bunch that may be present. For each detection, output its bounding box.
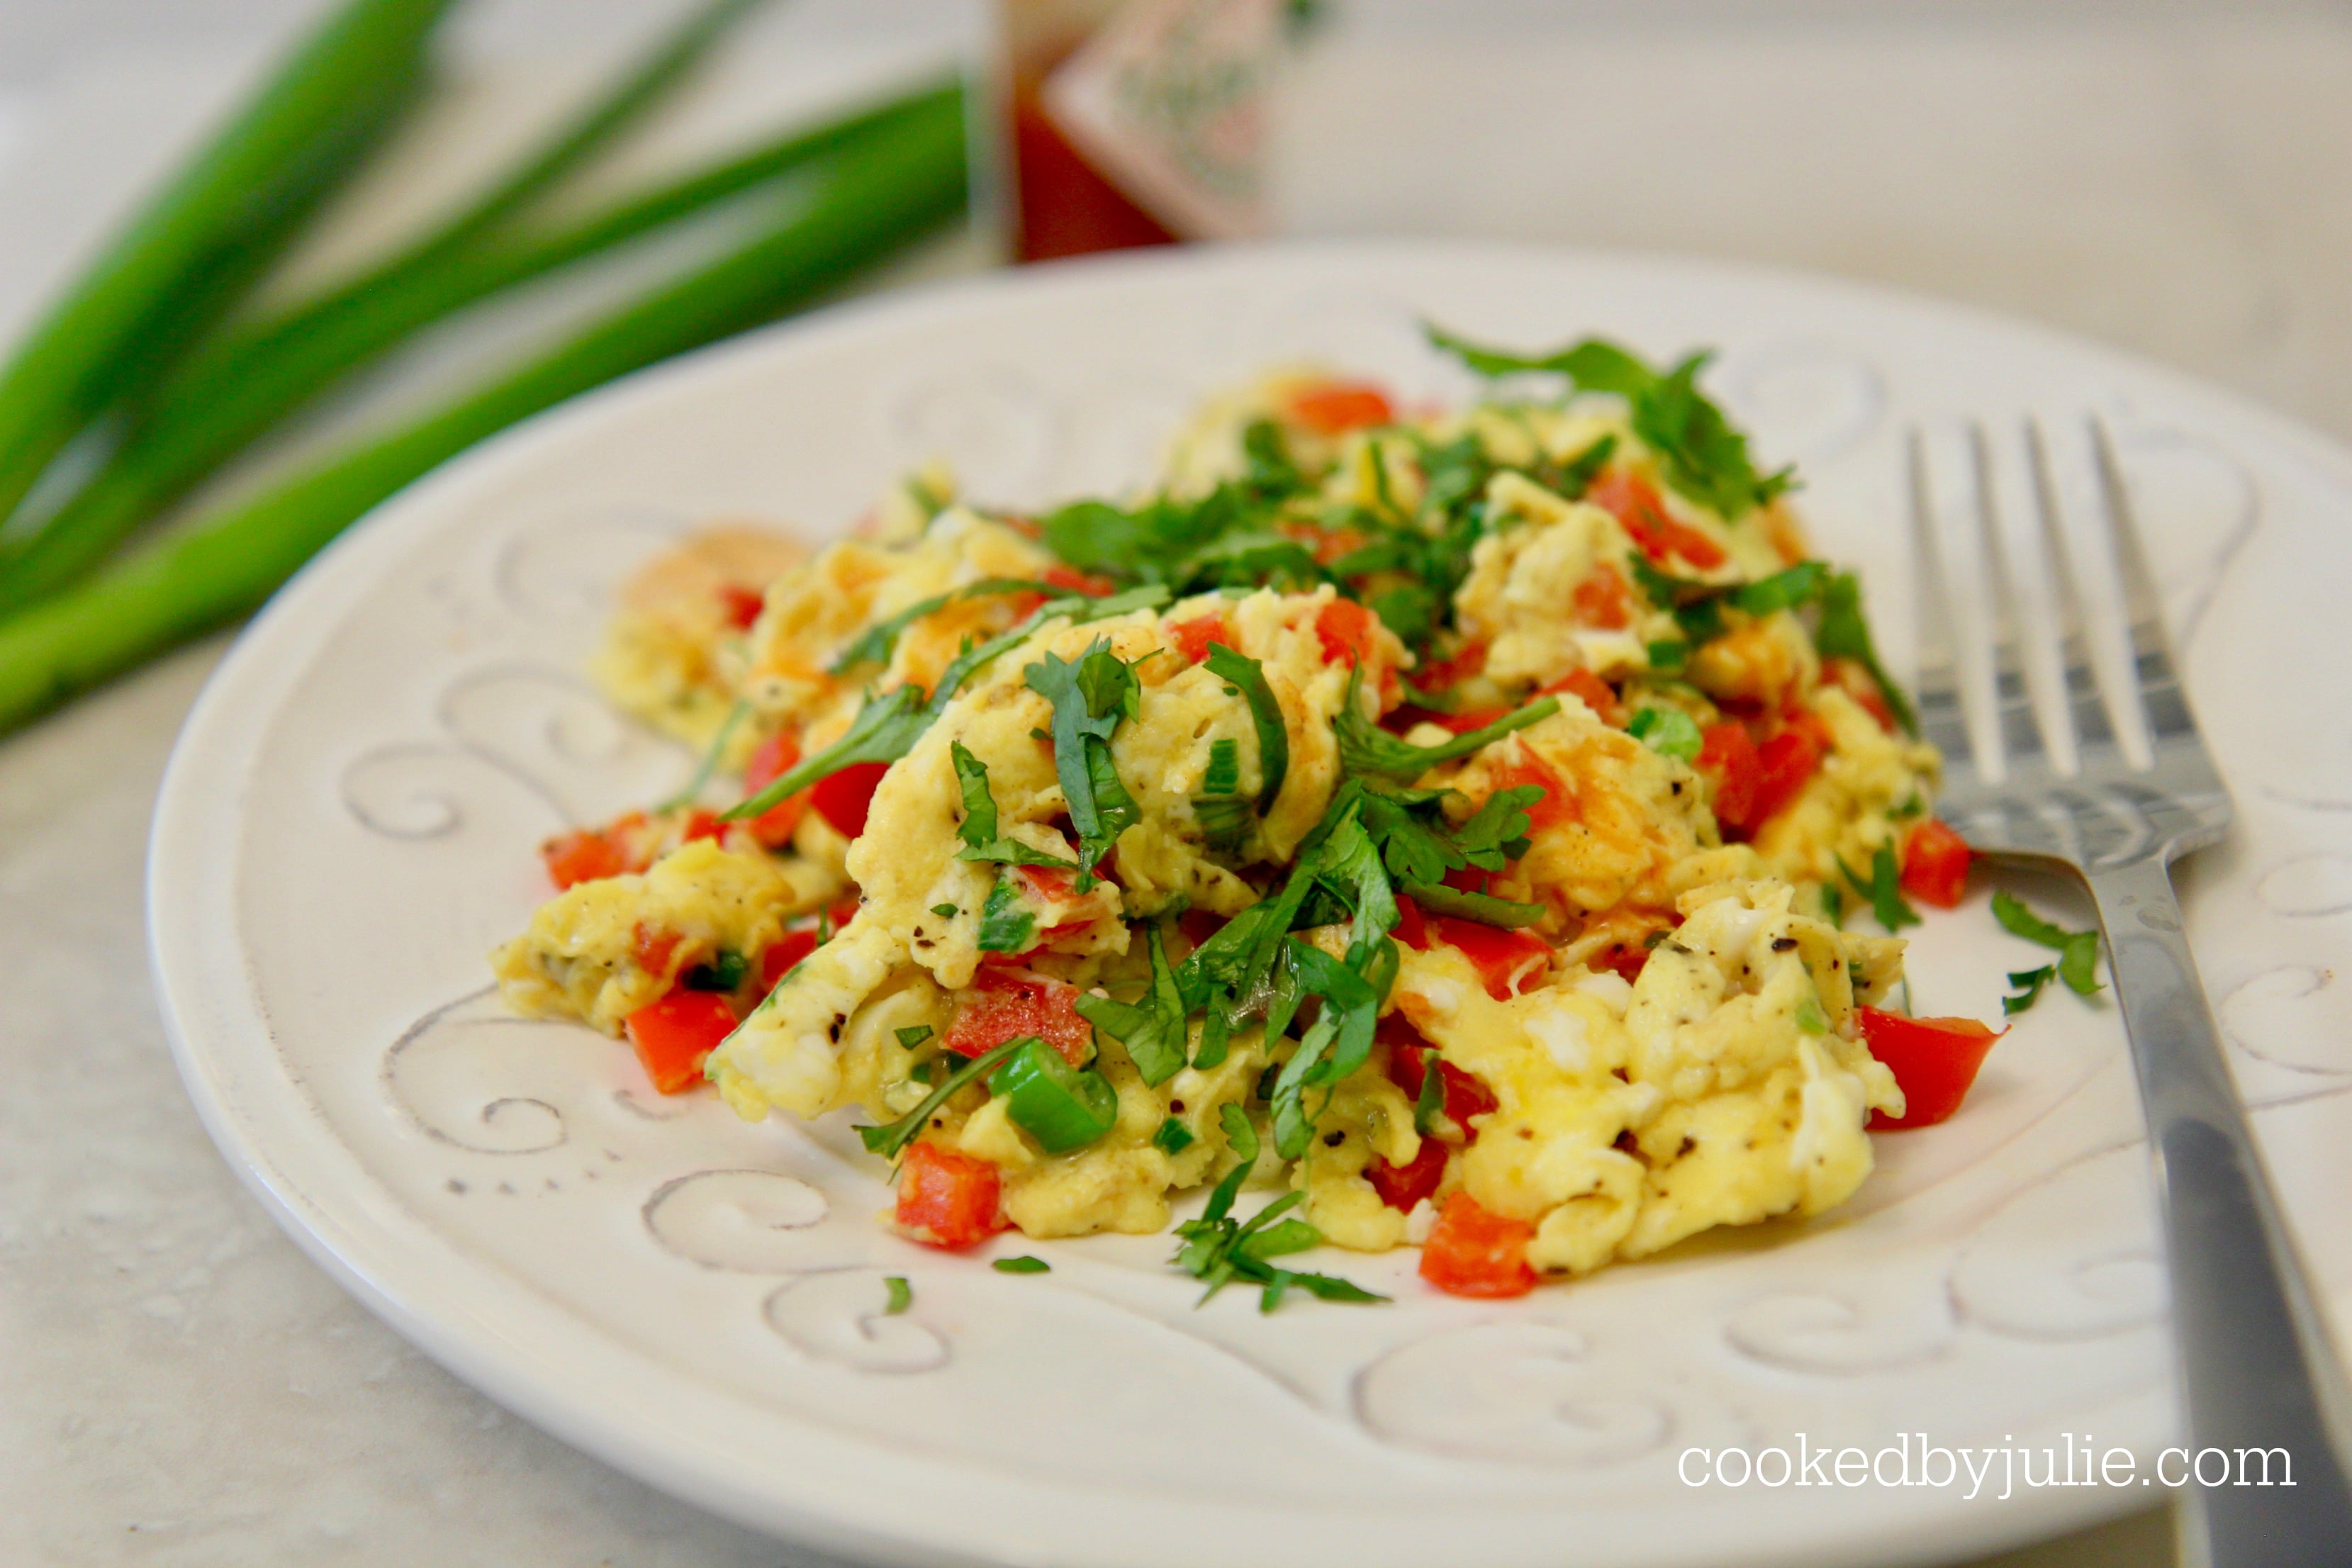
[0,93,964,729]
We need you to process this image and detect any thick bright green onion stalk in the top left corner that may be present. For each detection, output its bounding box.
[0,0,449,531]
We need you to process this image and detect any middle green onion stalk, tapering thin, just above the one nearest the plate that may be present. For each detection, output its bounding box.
[0,84,962,611]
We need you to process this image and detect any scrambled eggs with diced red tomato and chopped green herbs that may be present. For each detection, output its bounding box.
[494,343,1966,1302]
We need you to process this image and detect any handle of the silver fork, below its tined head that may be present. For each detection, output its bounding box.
[2088,856,2352,1568]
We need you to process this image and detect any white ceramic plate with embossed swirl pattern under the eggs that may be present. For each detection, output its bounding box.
[153,245,2352,1568]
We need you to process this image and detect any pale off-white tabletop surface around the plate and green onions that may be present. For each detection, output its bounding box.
[13,0,2352,1568]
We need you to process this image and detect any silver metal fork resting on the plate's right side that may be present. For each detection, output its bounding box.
[1910,418,2352,1568]
